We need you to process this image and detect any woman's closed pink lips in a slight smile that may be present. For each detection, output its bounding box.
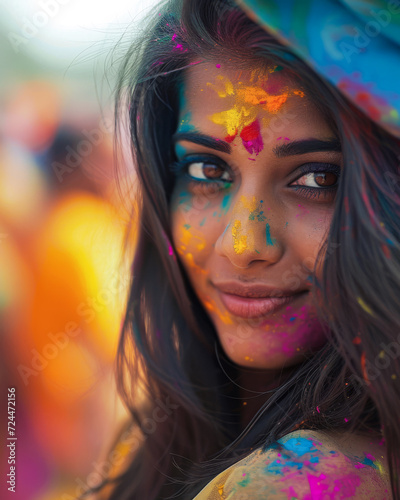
[213,282,308,318]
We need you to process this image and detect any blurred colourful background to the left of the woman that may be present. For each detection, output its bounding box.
[0,0,156,500]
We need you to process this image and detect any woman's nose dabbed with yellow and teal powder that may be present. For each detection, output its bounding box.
[215,195,284,269]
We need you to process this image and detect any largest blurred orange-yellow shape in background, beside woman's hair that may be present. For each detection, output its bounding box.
[12,192,129,474]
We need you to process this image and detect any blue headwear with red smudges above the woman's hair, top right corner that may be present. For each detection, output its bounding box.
[236,0,400,137]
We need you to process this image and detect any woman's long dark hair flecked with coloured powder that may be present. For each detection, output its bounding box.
[83,0,400,500]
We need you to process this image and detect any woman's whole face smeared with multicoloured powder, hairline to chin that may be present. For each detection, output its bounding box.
[171,61,341,369]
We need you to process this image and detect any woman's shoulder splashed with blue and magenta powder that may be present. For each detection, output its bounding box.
[195,430,392,500]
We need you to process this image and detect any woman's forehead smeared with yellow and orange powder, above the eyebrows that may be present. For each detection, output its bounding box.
[180,61,323,135]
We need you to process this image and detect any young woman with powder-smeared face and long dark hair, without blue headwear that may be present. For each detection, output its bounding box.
[86,0,400,500]
